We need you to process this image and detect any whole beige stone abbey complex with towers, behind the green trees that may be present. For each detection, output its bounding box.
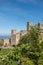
[0,22,43,47]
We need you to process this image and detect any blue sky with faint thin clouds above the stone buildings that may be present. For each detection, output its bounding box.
[0,0,43,34]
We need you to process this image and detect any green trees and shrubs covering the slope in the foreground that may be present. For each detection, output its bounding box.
[0,26,43,65]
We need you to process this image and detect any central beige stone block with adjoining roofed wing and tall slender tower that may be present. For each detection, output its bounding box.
[11,22,32,46]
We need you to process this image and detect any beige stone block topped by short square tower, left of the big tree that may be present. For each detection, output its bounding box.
[11,29,20,46]
